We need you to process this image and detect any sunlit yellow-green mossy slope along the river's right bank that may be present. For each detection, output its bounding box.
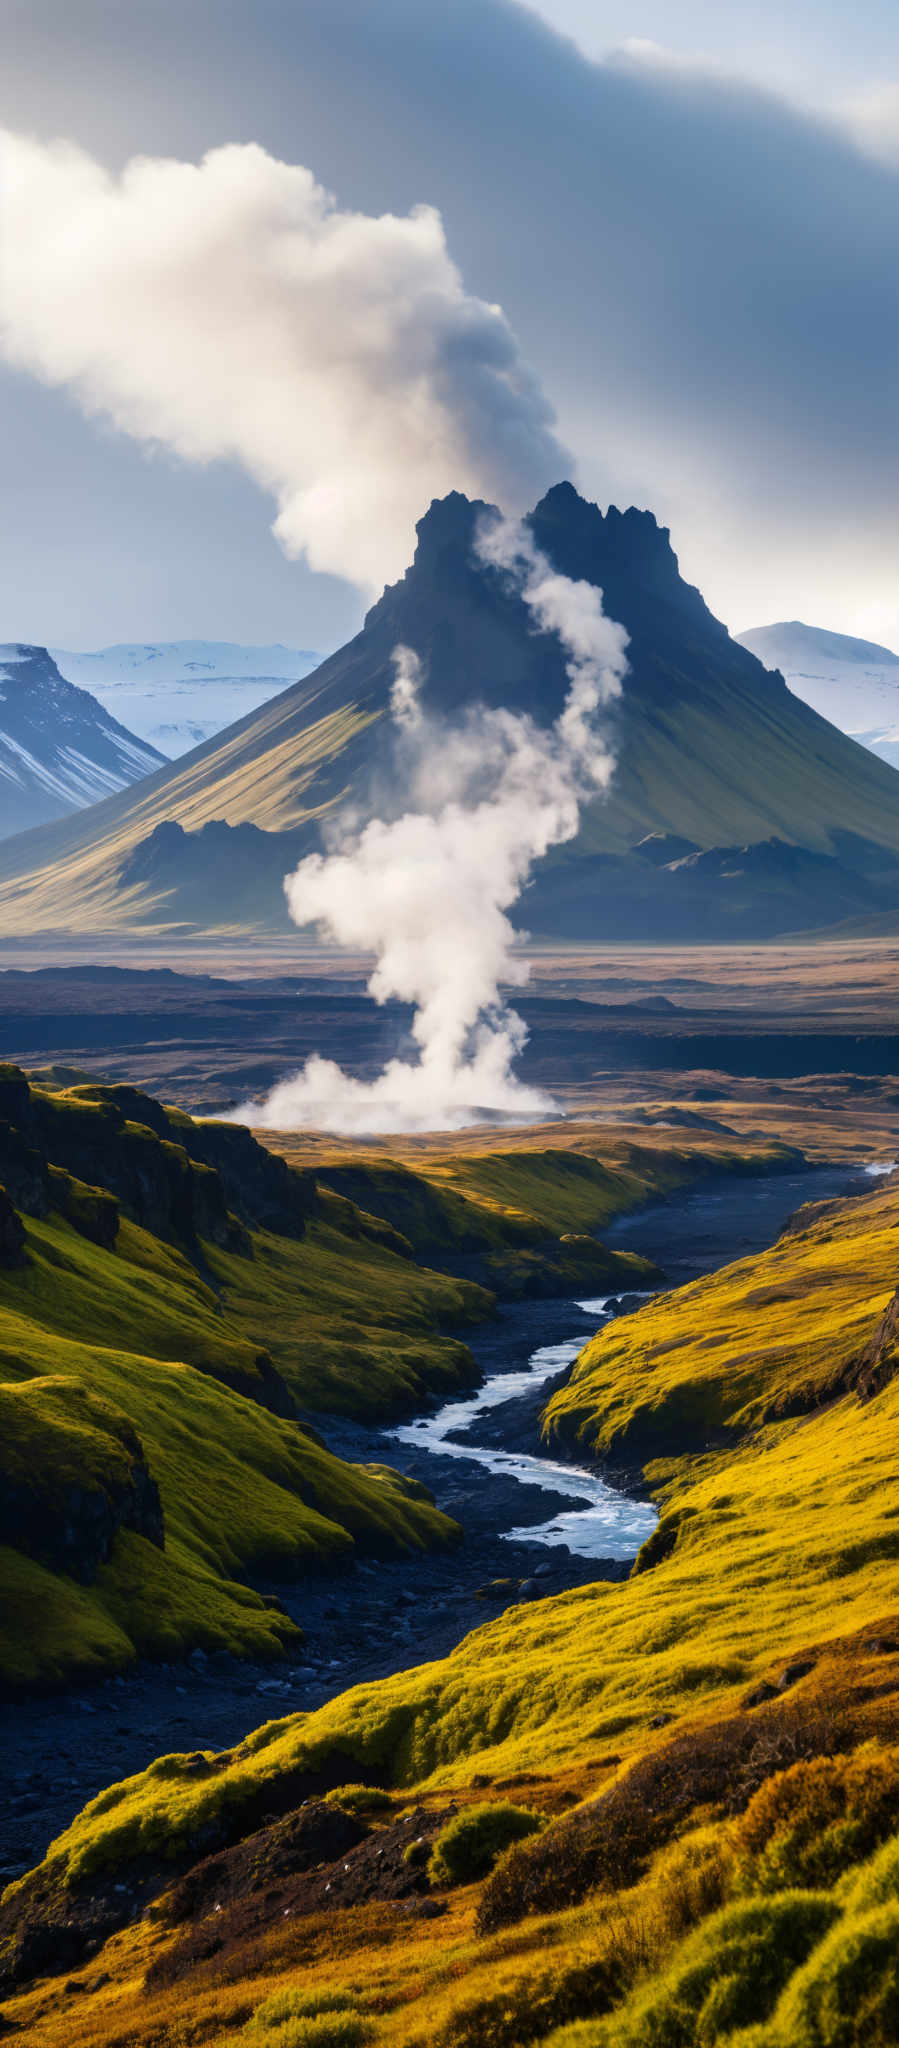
[21,1190,899,1900]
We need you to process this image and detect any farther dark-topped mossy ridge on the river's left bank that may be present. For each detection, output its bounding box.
[0,1067,491,1419]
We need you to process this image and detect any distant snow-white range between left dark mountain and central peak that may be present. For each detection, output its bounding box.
[51,641,322,760]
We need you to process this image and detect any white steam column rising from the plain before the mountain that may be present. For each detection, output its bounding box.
[233,520,627,1135]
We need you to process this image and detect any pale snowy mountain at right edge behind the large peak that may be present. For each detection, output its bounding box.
[739,618,899,768]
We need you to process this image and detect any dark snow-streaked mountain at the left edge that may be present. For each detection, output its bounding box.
[0,641,162,838]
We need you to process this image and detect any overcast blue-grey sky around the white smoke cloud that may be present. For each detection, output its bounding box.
[0,0,899,649]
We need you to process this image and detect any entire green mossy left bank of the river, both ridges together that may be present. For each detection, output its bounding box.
[0,1069,491,1690]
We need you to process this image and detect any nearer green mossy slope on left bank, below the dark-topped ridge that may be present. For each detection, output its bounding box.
[0,1223,455,1688]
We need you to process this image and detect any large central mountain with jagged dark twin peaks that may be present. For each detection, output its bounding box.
[0,483,899,940]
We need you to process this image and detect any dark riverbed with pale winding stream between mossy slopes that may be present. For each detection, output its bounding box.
[0,1167,870,1882]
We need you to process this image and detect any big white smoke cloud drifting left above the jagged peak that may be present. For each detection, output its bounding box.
[0,129,571,590]
